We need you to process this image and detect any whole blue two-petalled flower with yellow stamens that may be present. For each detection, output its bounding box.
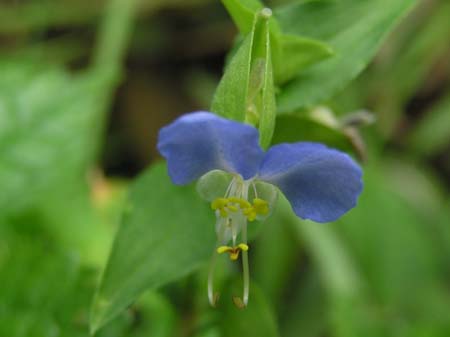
[158,112,362,305]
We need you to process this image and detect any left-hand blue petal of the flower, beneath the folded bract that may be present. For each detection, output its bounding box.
[158,112,264,185]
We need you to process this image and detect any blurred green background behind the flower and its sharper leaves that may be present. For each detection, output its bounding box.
[0,0,450,337]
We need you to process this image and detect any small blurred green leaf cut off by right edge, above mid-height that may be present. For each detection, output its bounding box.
[410,94,450,156]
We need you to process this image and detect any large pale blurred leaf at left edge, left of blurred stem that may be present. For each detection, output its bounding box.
[0,62,116,212]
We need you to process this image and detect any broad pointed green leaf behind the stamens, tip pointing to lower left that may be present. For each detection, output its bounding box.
[91,164,215,331]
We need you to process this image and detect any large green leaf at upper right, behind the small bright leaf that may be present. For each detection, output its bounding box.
[276,0,416,113]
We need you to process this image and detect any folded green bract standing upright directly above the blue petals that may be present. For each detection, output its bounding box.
[211,12,276,148]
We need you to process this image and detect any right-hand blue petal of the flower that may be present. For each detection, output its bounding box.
[259,142,362,222]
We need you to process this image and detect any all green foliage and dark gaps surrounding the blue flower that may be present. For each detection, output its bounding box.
[0,0,450,337]
